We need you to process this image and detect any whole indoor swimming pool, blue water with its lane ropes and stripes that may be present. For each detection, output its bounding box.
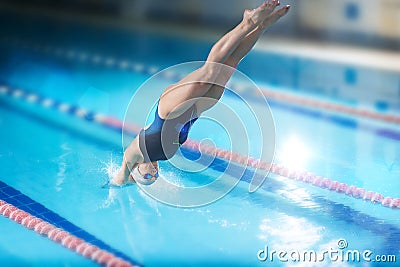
[0,9,400,266]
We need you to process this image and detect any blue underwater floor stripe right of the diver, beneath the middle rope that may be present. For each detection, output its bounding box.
[181,147,400,254]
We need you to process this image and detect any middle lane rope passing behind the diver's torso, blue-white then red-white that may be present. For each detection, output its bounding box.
[0,85,400,209]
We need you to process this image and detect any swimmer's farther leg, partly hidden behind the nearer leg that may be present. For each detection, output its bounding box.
[196,2,290,115]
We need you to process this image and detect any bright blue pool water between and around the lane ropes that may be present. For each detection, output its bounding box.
[0,10,400,266]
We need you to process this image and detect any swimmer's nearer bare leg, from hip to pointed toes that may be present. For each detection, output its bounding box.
[158,0,278,118]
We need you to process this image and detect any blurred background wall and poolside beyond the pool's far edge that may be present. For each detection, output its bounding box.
[0,0,400,50]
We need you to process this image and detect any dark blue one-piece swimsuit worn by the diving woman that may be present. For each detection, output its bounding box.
[139,105,198,162]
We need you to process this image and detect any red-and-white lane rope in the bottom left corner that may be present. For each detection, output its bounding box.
[0,200,135,267]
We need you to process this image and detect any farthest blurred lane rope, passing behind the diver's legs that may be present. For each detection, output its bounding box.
[3,38,400,124]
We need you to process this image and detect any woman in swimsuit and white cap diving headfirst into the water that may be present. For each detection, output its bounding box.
[110,0,290,186]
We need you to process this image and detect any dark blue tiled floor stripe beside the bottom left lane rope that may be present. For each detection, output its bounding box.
[0,181,139,265]
